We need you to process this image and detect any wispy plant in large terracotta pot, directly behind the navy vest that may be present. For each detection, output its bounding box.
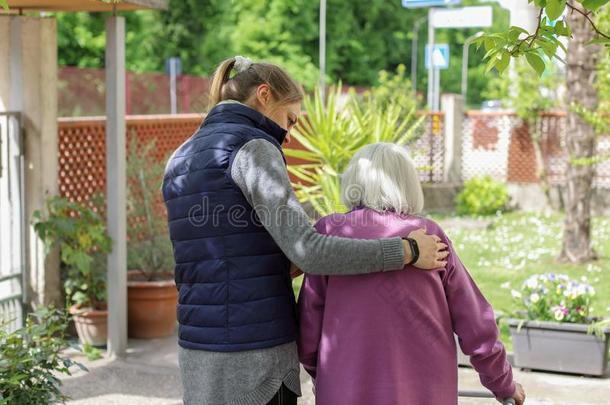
[127,137,178,338]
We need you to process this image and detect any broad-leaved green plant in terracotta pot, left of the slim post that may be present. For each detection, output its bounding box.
[34,197,112,346]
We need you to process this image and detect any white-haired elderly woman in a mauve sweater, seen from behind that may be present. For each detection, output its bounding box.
[298,143,525,405]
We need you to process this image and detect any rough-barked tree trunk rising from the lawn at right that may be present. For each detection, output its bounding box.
[559,2,600,263]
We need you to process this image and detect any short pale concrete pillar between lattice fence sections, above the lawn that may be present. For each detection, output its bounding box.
[441,94,464,183]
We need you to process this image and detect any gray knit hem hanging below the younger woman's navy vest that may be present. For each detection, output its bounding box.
[178,342,301,405]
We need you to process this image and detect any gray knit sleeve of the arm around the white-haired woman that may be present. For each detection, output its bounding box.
[230,139,404,275]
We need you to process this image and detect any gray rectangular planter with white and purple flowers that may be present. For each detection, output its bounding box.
[508,273,610,376]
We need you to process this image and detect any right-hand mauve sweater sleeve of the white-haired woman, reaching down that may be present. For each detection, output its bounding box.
[444,239,515,399]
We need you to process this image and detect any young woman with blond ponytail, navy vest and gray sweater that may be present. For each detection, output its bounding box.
[163,57,447,405]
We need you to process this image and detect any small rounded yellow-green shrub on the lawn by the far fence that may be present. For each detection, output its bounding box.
[455,176,508,216]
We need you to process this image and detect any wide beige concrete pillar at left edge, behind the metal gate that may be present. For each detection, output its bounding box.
[0,16,62,305]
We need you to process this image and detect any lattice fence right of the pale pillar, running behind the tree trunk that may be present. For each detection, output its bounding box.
[462,111,610,189]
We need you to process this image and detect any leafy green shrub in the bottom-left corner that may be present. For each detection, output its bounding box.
[0,308,87,405]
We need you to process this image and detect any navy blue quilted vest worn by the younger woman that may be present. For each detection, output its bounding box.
[163,103,296,352]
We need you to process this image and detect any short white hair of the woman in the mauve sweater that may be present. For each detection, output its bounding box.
[341,143,424,214]
